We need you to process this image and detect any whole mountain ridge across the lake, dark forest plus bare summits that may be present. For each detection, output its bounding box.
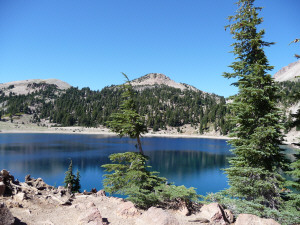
[0,73,230,134]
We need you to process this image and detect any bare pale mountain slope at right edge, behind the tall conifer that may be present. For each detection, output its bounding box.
[274,60,300,82]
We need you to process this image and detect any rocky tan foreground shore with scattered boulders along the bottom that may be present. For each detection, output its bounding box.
[0,169,279,225]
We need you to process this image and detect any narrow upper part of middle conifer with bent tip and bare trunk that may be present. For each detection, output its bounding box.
[107,73,147,154]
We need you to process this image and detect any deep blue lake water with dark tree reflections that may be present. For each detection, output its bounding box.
[0,134,231,194]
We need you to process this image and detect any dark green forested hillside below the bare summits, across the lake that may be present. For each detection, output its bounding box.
[0,80,229,134]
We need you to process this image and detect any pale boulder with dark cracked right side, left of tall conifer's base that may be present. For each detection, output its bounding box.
[196,203,229,225]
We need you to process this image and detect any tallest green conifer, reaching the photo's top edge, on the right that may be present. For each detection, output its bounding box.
[224,0,284,209]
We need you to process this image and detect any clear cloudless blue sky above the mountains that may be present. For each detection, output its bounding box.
[0,0,300,97]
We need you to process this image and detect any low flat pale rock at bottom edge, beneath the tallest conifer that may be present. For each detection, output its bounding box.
[235,214,280,225]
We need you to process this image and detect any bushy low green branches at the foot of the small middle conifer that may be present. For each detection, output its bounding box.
[102,152,197,208]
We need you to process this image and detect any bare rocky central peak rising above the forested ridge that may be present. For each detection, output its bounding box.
[131,73,199,91]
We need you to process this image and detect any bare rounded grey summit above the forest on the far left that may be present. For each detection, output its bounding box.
[0,79,71,95]
